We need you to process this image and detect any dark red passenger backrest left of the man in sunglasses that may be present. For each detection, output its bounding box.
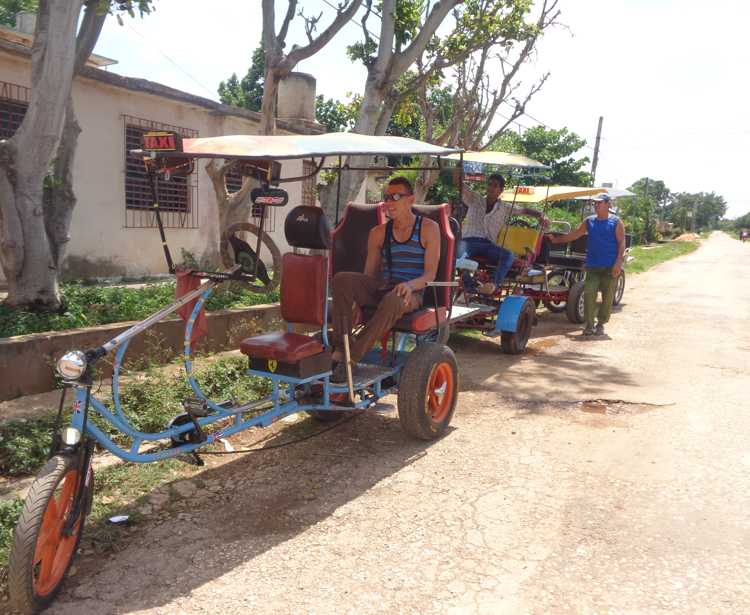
[331,203,386,275]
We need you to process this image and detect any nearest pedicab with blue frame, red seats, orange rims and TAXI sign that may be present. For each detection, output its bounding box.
[8,133,500,613]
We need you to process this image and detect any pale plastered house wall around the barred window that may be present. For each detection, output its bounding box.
[0,53,302,278]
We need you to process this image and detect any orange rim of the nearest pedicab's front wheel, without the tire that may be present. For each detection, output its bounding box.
[34,470,82,596]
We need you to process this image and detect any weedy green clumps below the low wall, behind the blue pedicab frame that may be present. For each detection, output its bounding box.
[0,357,269,476]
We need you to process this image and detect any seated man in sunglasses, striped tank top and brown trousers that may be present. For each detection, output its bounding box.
[331,177,440,382]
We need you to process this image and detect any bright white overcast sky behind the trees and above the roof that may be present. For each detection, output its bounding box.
[96,0,750,216]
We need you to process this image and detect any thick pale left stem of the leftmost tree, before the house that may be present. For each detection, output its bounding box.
[0,0,82,309]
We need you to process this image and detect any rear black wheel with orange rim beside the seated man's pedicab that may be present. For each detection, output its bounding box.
[398,342,458,440]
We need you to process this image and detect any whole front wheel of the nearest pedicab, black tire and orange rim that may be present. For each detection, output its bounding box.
[8,454,94,615]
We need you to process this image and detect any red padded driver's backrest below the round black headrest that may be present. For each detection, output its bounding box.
[281,252,328,326]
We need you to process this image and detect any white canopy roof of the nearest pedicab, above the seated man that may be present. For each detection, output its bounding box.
[176,132,460,160]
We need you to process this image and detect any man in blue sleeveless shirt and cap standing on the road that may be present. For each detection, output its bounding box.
[550,193,625,335]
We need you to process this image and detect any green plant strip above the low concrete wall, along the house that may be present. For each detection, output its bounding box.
[0,282,279,337]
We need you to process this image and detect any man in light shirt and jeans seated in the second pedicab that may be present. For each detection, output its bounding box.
[458,174,528,295]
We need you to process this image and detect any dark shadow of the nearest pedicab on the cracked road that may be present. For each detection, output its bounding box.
[60,413,450,613]
